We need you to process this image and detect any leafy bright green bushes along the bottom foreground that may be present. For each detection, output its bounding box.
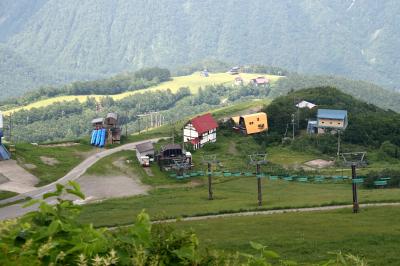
[0,182,366,266]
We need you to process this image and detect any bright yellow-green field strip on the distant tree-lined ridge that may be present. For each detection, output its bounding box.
[3,72,282,115]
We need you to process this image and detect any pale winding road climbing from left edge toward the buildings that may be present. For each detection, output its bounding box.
[0,138,164,220]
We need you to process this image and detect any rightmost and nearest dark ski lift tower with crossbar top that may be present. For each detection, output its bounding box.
[341,151,367,213]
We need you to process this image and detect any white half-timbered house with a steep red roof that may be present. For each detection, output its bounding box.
[183,114,218,149]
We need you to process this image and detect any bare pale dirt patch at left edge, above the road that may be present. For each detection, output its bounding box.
[0,160,39,193]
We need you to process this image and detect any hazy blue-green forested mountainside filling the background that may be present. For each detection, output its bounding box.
[0,0,400,98]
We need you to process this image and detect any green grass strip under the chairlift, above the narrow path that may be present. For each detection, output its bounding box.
[80,177,400,226]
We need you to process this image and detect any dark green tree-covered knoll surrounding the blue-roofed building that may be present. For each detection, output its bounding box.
[260,87,400,153]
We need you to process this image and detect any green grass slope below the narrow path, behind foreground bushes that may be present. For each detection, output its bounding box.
[173,207,400,265]
